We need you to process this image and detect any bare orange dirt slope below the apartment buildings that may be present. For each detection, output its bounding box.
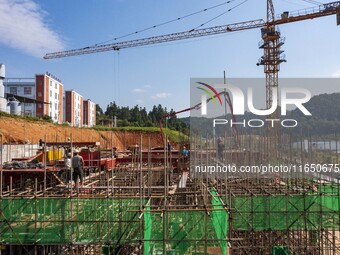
[0,117,162,150]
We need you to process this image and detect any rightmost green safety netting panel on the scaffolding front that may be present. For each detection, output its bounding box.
[231,185,340,231]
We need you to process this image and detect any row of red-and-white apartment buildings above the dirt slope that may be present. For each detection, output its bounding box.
[0,65,96,127]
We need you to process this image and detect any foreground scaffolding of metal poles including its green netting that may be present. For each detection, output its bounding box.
[0,132,340,255]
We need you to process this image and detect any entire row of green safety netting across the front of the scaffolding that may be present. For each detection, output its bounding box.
[0,184,340,254]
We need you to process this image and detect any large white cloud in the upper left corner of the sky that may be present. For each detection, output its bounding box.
[0,0,64,57]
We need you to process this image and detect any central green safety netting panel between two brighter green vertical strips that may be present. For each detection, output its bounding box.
[144,210,221,254]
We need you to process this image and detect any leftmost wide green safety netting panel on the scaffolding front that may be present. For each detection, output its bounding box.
[0,198,142,244]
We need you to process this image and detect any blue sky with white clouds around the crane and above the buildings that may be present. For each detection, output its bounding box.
[0,0,340,114]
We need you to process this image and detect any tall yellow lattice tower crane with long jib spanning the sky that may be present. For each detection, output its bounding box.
[44,0,340,157]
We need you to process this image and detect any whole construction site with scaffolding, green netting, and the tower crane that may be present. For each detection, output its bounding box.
[0,0,340,255]
